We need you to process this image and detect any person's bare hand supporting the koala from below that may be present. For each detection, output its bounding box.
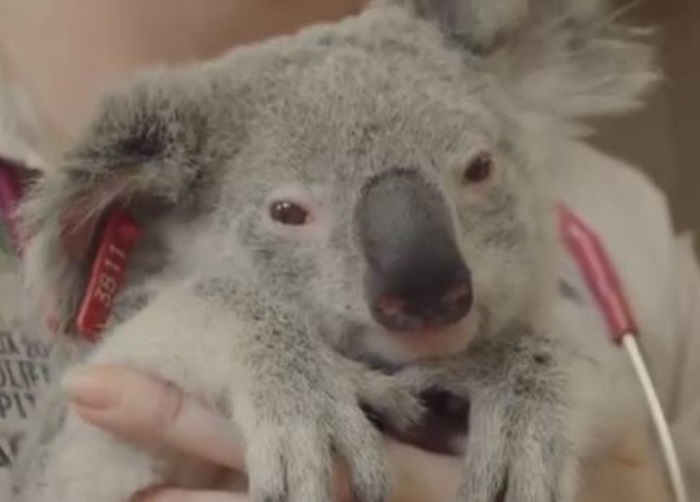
[66,366,461,502]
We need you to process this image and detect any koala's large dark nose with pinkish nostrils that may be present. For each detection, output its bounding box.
[357,169,473,332]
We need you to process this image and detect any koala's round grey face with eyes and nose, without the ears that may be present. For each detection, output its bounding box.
[198,8,546,358]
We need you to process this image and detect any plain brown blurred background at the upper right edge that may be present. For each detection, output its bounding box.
[593,0,700,252]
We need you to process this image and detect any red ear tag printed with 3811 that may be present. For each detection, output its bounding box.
[75,209,141,341]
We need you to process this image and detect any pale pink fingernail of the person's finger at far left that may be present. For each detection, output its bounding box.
[62,369,122,411]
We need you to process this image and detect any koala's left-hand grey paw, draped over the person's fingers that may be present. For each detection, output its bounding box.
[234,361,421,502]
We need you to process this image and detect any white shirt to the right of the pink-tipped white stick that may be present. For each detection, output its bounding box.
[556,143,700,500]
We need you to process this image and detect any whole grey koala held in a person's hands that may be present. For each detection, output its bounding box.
[9,0,655,502]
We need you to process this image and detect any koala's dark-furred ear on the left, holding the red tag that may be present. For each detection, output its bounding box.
[19,77,212,338]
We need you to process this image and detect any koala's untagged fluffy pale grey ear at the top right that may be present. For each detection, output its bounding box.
[395,0,658,127]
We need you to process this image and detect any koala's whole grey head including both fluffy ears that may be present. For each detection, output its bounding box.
[24,0,651,358]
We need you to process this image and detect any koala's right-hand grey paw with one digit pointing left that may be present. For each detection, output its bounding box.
[404,327,580,502]
